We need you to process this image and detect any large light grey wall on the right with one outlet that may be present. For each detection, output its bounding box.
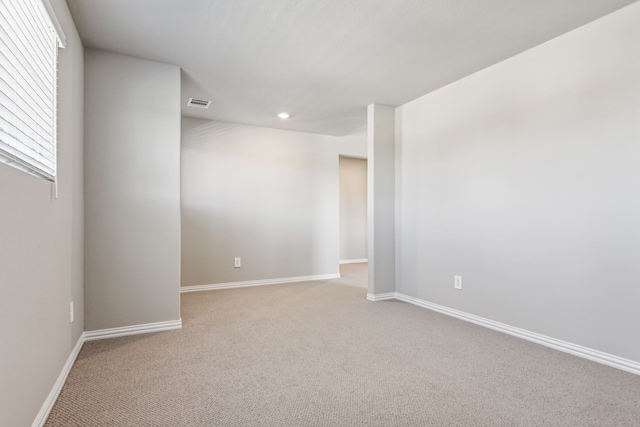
[396,3,640,361]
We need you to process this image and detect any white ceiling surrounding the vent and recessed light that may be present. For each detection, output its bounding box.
[68,0,635,135]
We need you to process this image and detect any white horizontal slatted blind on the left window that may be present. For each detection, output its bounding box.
[0,0,59,181]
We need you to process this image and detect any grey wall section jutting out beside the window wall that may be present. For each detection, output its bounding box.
[84,50,180,331]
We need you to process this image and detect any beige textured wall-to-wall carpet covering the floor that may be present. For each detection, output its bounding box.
[46,265,640,426]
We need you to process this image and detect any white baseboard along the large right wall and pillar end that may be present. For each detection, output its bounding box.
[367,292,640,375]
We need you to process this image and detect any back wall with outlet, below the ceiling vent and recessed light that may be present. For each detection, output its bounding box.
[182,118,366,286]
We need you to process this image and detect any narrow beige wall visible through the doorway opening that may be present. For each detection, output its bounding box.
[340,157,367,261]
